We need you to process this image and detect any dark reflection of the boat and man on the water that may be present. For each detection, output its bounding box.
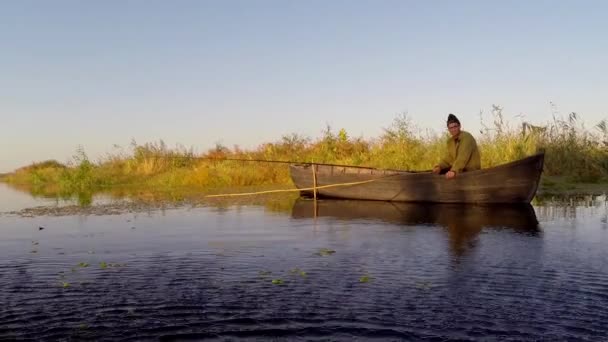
[292,198,540,255]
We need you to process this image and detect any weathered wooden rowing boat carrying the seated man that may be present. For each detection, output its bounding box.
[290,153,544,203]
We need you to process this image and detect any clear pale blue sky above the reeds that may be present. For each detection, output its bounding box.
[0,0,608,172]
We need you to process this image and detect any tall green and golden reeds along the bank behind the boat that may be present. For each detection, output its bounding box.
[4,106,608,199]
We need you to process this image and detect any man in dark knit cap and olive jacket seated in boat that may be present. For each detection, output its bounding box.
[433,114,481,179]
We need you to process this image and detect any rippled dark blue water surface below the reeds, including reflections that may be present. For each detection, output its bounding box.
[0,188,608,341]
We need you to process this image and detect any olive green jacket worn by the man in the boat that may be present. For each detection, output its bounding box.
[438,131,481,173]
